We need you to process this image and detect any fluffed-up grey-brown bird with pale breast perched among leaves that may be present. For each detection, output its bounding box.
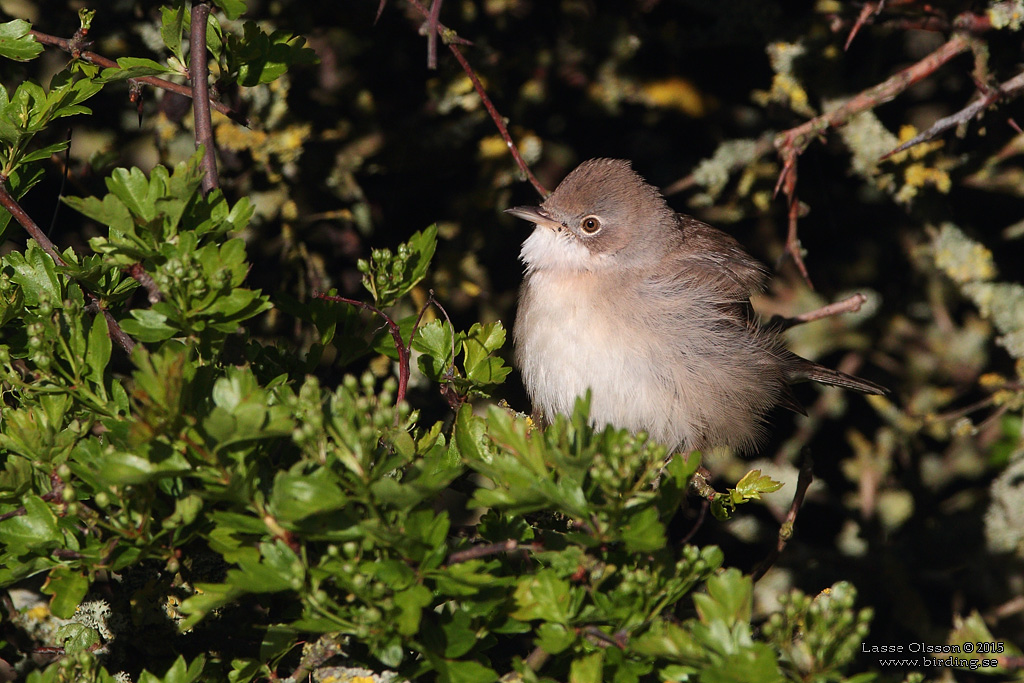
[506,159,887,452]
